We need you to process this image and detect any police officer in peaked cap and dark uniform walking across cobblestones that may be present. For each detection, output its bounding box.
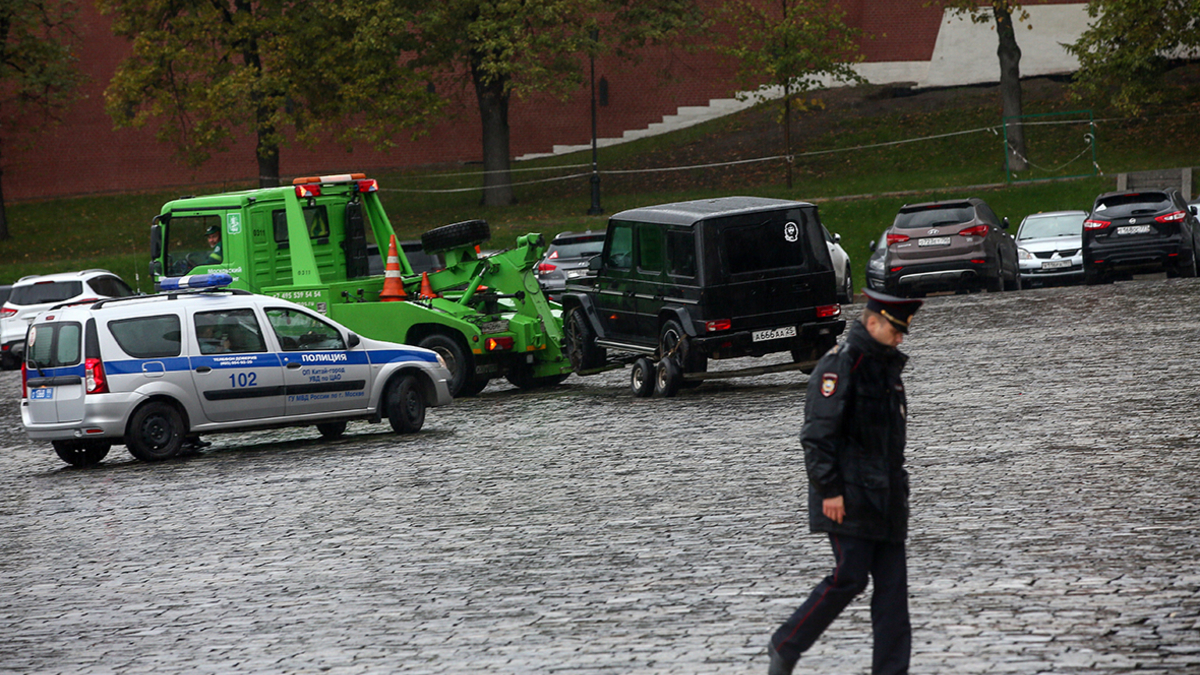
[767,291,922,675]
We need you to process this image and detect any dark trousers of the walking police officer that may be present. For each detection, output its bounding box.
[772,533,912,675]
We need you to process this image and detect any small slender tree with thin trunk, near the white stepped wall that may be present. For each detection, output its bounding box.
[718,0,865,187]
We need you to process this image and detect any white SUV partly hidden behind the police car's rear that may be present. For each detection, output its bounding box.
[0,269,133,370]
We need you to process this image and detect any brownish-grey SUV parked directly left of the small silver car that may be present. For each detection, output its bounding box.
[884,197,1021,295]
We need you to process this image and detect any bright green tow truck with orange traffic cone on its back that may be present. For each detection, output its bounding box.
[150,174,571,396]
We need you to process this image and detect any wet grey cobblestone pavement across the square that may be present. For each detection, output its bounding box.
[0,280,1200,675]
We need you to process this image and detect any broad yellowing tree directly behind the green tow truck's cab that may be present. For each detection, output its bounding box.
[98,0,437,187]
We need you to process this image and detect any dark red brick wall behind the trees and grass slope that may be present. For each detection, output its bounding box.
[0,0,1082,199]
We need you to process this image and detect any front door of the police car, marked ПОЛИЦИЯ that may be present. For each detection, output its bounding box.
[266,307,371,414]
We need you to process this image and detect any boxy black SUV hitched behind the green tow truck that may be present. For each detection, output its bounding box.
[562,197,846,396]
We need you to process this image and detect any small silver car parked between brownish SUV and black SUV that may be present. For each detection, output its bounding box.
[1016,211,1087,286]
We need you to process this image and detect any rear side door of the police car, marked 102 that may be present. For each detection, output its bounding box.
[191,307,286,422]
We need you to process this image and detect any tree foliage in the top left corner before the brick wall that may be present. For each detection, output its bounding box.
[0,0,83,239]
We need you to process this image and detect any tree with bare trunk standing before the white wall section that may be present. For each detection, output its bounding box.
[935,0,1033,172]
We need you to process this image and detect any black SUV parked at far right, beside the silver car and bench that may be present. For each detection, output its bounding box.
[1084,190,1200,283]
